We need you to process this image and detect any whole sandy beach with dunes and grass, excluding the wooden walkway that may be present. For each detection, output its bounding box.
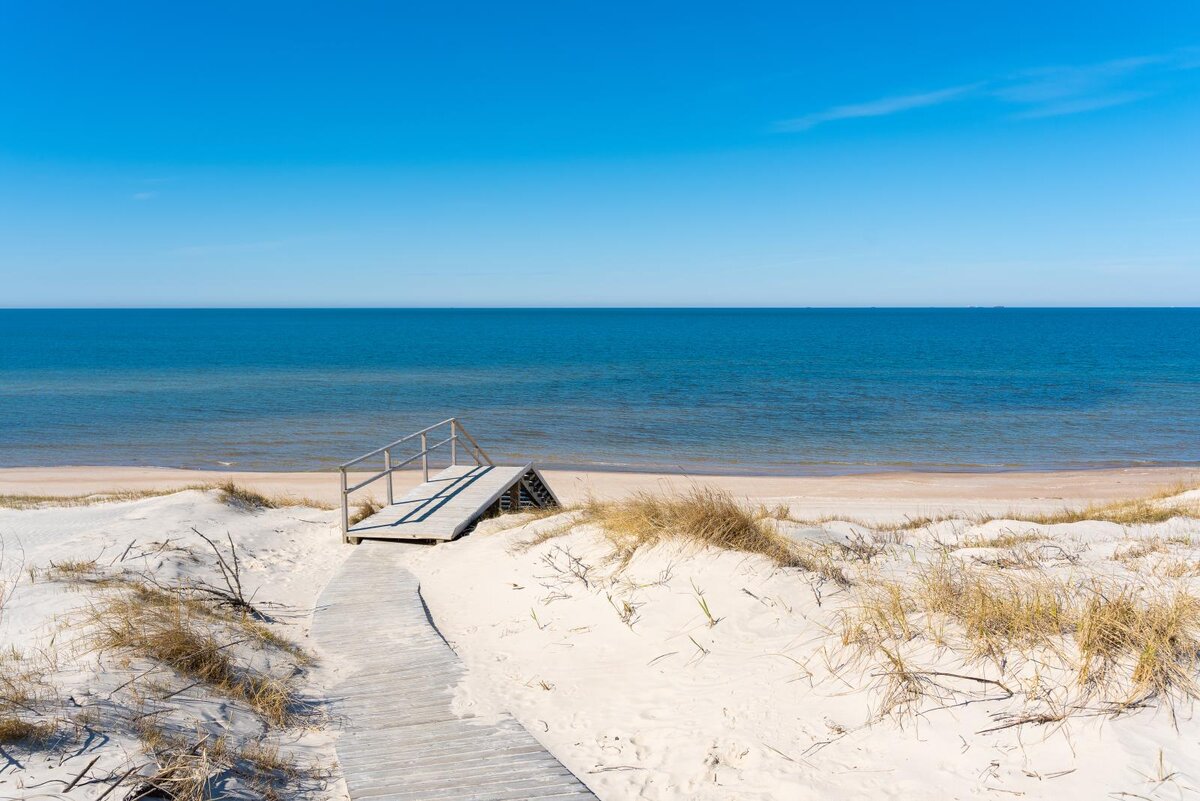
[0,468,1200,801]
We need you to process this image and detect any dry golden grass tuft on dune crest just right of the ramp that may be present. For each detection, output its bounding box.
[581,487,848,584]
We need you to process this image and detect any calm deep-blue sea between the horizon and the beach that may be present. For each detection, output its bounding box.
[0,309,1200,474]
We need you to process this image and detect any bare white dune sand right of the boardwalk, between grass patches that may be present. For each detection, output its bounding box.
[412,510,1200,801]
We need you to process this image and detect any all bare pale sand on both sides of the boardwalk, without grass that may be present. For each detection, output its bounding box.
[0,469,1200,801]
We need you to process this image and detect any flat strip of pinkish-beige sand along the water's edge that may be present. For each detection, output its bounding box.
[0,466,1200,519]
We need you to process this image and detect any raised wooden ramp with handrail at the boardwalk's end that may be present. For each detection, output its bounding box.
[341,417,559,543]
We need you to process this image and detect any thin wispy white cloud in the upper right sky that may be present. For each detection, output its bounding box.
[774,48,1200,132]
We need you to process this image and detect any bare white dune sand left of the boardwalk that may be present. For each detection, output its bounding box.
[0,492,348,799]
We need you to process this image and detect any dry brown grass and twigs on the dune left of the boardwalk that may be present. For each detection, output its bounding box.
[26,532,319,801]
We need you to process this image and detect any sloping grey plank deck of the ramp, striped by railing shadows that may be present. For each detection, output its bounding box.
[348,464,533,540]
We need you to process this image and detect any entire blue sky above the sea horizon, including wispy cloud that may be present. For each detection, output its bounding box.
[0,0,1200,306]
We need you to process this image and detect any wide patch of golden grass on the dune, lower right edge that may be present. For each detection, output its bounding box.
[841,559,1200,709]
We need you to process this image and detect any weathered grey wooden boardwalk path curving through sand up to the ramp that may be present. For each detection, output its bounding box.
[312,542,595,801]
